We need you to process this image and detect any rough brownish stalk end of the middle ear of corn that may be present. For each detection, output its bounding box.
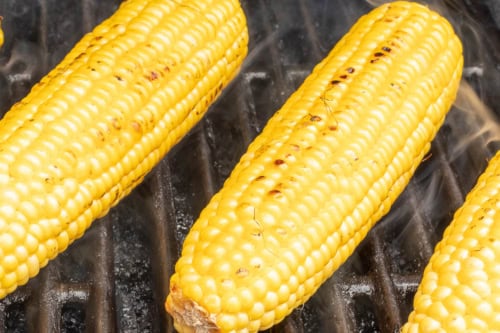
[165,284,220,333]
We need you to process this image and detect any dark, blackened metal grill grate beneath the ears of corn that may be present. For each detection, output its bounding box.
[0,0,500,333]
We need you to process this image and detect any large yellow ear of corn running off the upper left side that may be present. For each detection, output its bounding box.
[0,0,248,297]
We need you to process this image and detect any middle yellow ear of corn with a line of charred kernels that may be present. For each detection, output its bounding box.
[166,2,463,332]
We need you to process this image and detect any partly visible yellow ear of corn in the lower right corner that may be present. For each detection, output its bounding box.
[402,152,500,332]
